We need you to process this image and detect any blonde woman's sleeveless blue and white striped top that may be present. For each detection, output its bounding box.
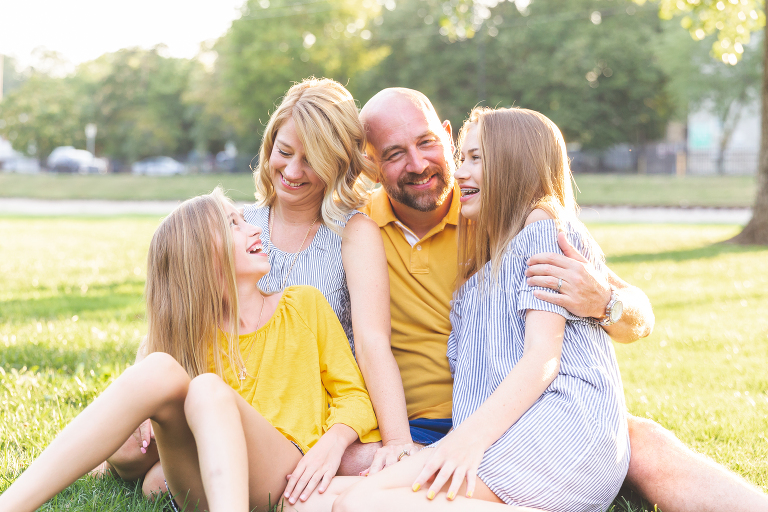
[243,204,356,355]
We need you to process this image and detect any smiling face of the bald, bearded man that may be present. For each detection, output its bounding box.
[366,92,453,212]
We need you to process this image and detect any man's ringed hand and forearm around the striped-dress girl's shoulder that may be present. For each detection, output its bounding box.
[525,233,655,343]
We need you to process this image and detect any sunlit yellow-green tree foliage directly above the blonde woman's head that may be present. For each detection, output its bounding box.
[215,0,386,154]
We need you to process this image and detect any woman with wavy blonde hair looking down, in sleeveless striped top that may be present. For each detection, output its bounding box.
[109,78,413,503]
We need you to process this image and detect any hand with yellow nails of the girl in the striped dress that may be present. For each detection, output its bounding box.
[412,425,486,500]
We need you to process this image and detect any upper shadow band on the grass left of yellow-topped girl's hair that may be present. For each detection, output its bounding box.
[0,280,144,322]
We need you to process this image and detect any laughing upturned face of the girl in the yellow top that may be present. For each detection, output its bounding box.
[224,203,270,282]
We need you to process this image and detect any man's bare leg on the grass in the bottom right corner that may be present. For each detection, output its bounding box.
[627,416,768,512]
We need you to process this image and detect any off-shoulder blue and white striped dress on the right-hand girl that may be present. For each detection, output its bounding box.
[448,220,629,512]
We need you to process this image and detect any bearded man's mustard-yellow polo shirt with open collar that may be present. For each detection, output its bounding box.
[363,188,460,420]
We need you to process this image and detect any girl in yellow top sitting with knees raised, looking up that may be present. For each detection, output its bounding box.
[0,190,380,512]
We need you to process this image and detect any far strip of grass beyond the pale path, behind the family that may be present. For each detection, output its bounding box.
[0,173,757,207]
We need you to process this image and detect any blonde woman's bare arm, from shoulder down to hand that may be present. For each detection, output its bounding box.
[341,215,412,473]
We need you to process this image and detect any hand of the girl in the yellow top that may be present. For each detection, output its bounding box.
[283,423,357,505]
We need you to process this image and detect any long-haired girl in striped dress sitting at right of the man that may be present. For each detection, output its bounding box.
[334,108,630,512]
